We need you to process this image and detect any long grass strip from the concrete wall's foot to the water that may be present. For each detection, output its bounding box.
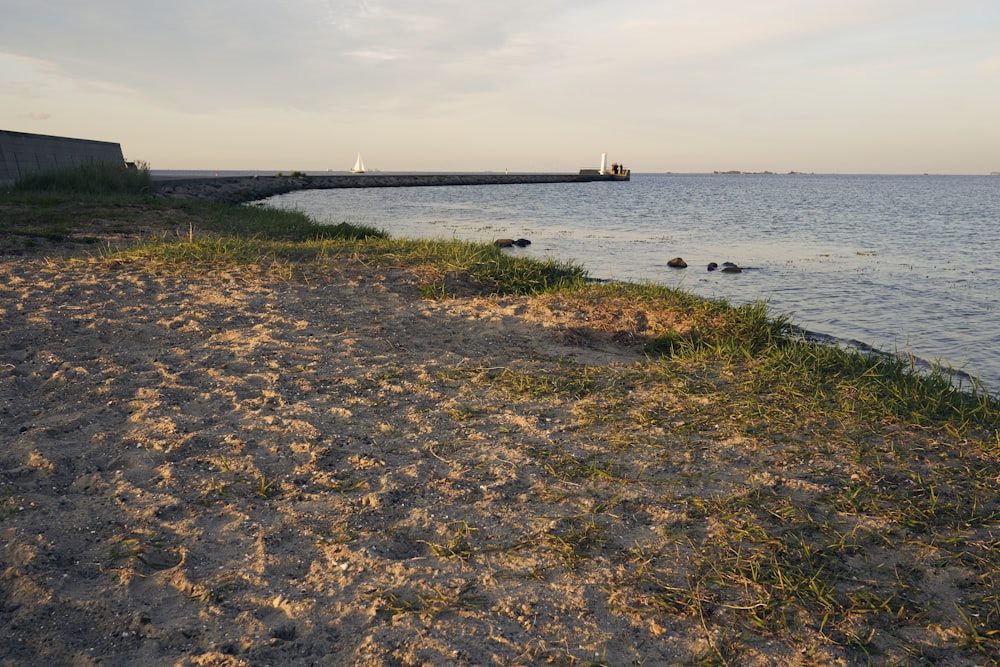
[0,177,586,297]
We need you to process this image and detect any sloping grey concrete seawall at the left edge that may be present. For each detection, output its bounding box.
[0,130,125,186]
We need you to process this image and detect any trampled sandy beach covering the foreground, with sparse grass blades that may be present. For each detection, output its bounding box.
[0,205,996,666]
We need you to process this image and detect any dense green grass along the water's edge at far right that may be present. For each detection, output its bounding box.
[646,282,1000,429]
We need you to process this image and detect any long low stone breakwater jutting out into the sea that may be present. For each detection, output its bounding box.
[153,174,626,204]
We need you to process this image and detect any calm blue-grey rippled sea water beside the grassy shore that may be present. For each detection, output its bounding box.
[267,174,1000,392]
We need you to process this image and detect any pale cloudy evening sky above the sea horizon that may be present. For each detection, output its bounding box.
[0,0,1000,174]
